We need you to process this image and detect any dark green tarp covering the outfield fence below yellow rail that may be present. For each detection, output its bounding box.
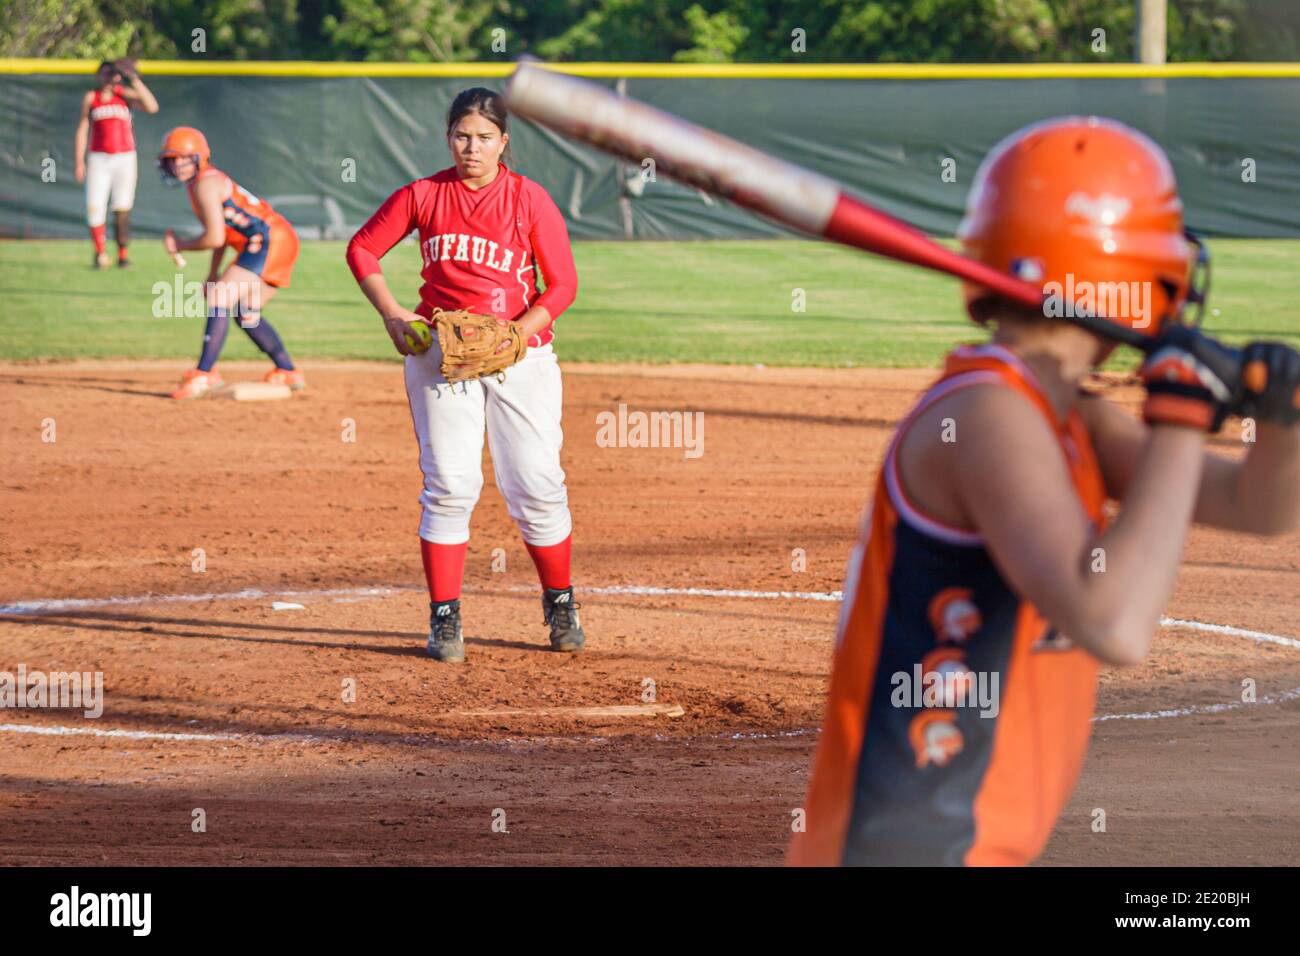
[0,68,1300,239]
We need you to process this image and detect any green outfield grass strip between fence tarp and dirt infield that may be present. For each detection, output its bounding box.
[0,239,1300,365]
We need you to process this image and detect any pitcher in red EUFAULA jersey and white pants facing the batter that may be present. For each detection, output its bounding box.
[347,87,585,662]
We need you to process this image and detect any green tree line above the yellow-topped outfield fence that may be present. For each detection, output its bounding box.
[0,0,1300,62]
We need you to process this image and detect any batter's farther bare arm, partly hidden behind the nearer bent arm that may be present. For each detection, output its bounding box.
[1080,379,1300,535]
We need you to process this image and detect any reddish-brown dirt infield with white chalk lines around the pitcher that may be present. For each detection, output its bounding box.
[0,363,1300,865]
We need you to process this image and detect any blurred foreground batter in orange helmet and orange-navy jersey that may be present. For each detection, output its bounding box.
[789,117,1300,865]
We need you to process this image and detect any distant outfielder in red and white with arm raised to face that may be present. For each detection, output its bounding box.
[75,60,159,269]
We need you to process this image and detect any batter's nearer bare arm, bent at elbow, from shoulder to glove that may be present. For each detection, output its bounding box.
[900,386,1204,663]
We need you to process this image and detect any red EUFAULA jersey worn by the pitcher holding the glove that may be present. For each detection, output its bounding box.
[347,164,577,347]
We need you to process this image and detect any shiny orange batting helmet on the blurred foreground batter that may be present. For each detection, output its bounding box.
[958,116,1208,342]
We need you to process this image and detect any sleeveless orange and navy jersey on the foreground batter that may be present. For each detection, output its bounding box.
[789,345,1106,865]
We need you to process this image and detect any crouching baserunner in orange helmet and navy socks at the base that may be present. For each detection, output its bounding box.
[159,126,307,399]
